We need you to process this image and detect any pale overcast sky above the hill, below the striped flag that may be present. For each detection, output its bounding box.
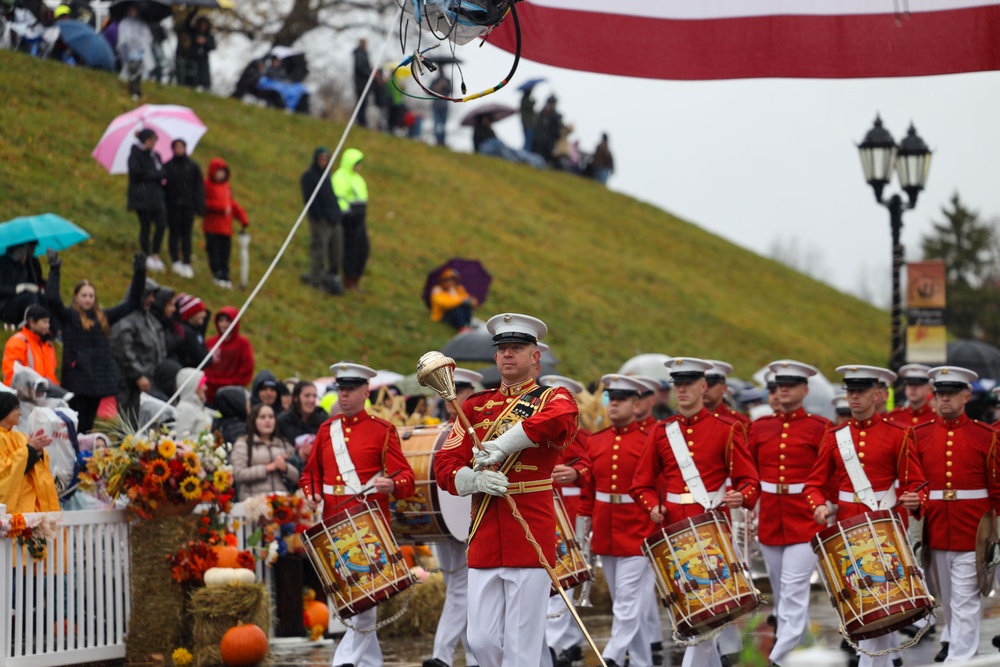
[440,44,1000,305]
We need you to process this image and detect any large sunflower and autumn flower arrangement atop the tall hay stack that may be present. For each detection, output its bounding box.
[80,430,234,519]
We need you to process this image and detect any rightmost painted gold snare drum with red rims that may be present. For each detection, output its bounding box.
[812,510,934,641]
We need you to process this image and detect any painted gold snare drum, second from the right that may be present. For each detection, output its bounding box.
[642,512,760,638]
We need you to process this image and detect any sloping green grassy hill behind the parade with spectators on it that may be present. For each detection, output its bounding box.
[0,51,889,380]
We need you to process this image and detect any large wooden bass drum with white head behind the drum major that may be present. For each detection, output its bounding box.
[389,425,472,542]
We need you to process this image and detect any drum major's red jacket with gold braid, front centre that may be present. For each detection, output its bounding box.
[434,380,579,568]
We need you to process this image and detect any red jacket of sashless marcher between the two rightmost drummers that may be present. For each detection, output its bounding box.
[750,408,832,547]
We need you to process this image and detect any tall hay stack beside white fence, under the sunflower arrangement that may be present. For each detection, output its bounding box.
[125,514,198,664]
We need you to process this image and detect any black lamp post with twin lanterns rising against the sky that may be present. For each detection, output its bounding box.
[858,116,931,380]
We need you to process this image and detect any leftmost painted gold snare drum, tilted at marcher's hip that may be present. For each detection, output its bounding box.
[303,504,416,619]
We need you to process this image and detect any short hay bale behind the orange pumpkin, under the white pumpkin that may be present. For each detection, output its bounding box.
[188,583,271,667]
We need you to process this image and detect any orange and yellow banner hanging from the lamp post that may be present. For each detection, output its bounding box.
[906,260,948,364]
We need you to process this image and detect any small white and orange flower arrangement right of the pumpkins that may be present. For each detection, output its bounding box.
[243,493,314,564]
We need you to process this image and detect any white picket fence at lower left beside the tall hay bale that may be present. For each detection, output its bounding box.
[0,504,336,667]
